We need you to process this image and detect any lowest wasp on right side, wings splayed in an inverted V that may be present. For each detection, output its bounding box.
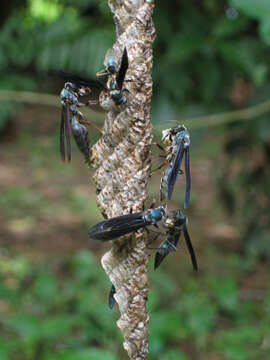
[154,210,198,271]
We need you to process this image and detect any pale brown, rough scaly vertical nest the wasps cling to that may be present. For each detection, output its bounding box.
[91,0,155,360]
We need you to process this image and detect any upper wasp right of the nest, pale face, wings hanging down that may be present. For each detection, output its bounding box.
[158,125,191,209]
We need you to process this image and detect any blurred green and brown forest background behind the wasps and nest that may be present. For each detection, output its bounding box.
[0,0,270,360]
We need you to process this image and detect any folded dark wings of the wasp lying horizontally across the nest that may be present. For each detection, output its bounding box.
[88,212,147,241]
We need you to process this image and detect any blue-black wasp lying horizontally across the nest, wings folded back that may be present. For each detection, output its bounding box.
[88,206,168,241]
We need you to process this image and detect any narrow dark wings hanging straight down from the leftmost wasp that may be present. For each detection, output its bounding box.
[60,104,71,161]
